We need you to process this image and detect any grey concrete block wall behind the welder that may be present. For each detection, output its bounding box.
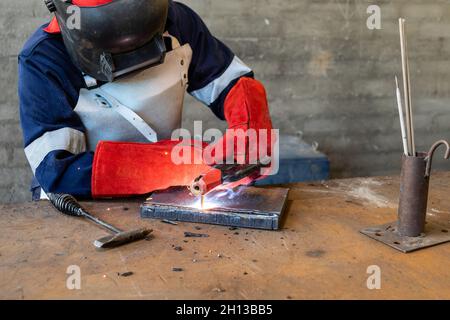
[0,0,450,202]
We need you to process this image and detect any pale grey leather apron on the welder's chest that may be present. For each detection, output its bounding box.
[74,37,192,151]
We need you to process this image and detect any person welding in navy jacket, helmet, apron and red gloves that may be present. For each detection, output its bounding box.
[19,0,272,199]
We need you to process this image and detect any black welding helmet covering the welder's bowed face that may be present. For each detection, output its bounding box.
[45,0,169,82]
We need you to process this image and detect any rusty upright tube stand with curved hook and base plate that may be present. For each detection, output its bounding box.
[361,140,450,253]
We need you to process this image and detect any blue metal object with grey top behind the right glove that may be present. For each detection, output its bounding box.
[255,136,330,186]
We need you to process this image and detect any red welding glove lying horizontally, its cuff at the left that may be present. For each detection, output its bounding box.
[91,141,221,198]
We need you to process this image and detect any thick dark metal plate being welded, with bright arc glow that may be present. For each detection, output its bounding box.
[141,187,289,230]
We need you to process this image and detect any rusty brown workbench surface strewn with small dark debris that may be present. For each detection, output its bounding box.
[0,173,450,299]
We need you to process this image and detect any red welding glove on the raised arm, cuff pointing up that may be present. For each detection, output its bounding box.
[211,77,275,164]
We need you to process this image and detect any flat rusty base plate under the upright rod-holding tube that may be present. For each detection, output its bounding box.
[361,221,450,253]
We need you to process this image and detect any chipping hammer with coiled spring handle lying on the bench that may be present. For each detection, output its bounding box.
[47,193,153,249]
